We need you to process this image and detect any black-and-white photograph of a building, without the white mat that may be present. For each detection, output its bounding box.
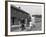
[11,5,42,32]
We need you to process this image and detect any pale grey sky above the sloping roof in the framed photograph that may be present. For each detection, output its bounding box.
[11,4,42,15]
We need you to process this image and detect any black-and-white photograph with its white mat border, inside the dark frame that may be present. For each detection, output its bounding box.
[7,2,44,35]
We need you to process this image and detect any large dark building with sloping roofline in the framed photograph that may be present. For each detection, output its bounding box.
[11,6,31,26]
